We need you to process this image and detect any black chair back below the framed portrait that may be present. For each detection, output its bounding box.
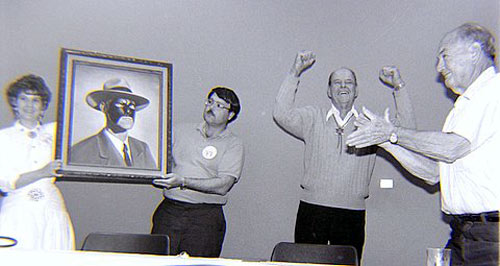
[81,233,170,255]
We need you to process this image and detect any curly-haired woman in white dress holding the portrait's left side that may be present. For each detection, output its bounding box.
[0,75,74,249]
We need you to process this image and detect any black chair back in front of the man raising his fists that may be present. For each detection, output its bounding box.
[271,242,359,266]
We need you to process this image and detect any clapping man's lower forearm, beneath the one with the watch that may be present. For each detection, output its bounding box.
[379,142,439,185]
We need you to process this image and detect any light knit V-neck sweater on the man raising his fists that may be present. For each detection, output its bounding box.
[273,75,414,210]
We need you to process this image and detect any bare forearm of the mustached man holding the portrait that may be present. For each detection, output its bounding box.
[183,176,236,196]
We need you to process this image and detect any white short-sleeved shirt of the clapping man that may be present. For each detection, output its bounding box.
[439,67,500,214]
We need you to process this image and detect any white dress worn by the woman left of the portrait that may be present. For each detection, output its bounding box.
[0,122,74,250]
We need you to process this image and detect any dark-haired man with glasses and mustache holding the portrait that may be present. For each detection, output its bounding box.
[151,87,244,257]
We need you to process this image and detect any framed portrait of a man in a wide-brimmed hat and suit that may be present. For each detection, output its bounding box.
[55,48,172,184]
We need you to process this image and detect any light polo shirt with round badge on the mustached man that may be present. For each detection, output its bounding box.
[163,123,244,205]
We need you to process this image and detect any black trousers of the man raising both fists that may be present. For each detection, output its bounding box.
[295,201,366,261]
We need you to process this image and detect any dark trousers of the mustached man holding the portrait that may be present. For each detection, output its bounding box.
[151,198,226,257]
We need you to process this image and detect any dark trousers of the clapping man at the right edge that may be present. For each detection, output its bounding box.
[446,212,500,266]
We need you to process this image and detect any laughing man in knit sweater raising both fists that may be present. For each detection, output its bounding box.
[273,51,415,259]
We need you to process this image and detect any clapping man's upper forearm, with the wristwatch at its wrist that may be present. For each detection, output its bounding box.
[396,127,471,163]
